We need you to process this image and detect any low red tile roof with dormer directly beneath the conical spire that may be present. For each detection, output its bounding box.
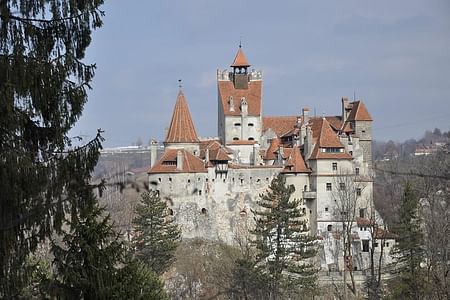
[148,149,207,174]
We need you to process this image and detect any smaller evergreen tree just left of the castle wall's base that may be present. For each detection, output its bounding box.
[133,191,181,274]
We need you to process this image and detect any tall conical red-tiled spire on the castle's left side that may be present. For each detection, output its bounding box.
[165,88,199,143]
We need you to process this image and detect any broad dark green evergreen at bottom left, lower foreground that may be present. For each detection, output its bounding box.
[49,206,166,299]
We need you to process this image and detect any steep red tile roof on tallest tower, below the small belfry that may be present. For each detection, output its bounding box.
[217,81,262,116]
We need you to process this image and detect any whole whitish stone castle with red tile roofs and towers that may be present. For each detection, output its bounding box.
[148,46,393,270]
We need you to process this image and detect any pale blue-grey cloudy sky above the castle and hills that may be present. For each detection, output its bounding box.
[71,0,450,147]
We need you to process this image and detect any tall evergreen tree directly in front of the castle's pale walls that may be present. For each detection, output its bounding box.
[253,174,317,299]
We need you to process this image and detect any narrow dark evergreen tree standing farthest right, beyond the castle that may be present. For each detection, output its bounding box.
[393,183,426,300]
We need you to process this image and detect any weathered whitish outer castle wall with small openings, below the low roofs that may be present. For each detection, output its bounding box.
[149,167,281,244]
